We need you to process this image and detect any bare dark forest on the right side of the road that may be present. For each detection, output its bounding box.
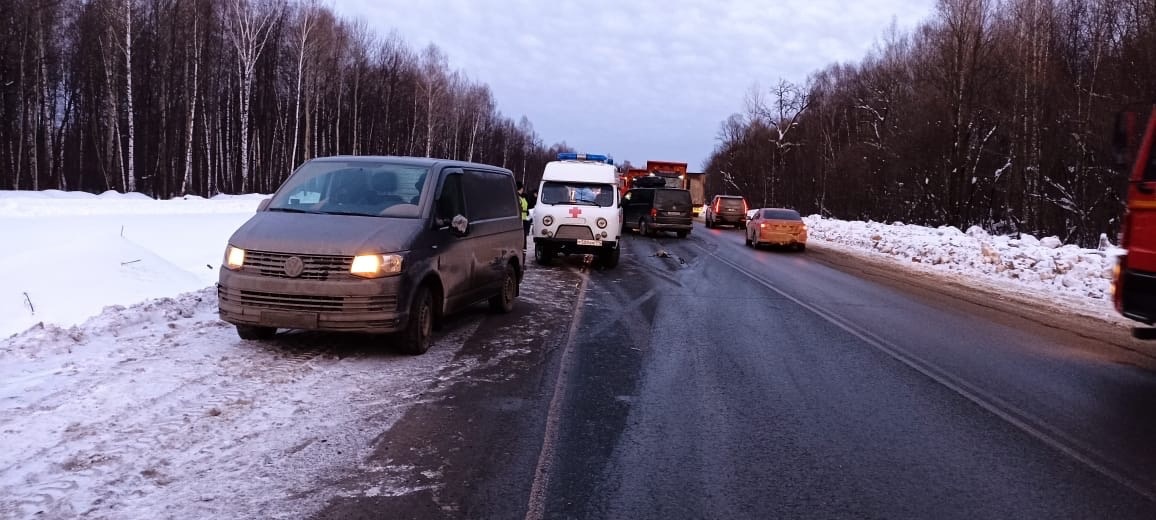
[704,0,1156,244]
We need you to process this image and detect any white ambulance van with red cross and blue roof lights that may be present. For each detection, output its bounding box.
[531,153,622,268]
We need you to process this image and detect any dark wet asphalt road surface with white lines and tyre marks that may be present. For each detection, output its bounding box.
[318,221,1156,519]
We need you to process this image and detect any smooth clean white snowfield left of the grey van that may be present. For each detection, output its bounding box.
[0,191,264,337]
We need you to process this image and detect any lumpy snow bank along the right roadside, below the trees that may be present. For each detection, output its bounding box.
[803,215,1124,299]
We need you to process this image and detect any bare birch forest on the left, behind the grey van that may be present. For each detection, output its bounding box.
[0,0,565,198]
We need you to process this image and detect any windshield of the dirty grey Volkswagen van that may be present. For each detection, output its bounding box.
[268,161,429,218]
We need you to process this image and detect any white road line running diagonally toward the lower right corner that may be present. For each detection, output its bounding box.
[698,246,1156,502]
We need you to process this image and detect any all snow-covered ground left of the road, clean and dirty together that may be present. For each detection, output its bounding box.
[0,192,564,520]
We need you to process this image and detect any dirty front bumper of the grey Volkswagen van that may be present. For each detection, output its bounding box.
[217,269,408,334]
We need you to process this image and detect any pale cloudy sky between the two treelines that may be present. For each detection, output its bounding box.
[334,0,935,170]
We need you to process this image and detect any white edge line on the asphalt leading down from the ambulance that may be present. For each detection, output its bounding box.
[526,272,590,520]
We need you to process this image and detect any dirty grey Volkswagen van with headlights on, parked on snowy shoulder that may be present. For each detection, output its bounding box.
[217,156,525,354]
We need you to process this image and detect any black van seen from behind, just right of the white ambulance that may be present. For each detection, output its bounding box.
[622,188,694,238]
